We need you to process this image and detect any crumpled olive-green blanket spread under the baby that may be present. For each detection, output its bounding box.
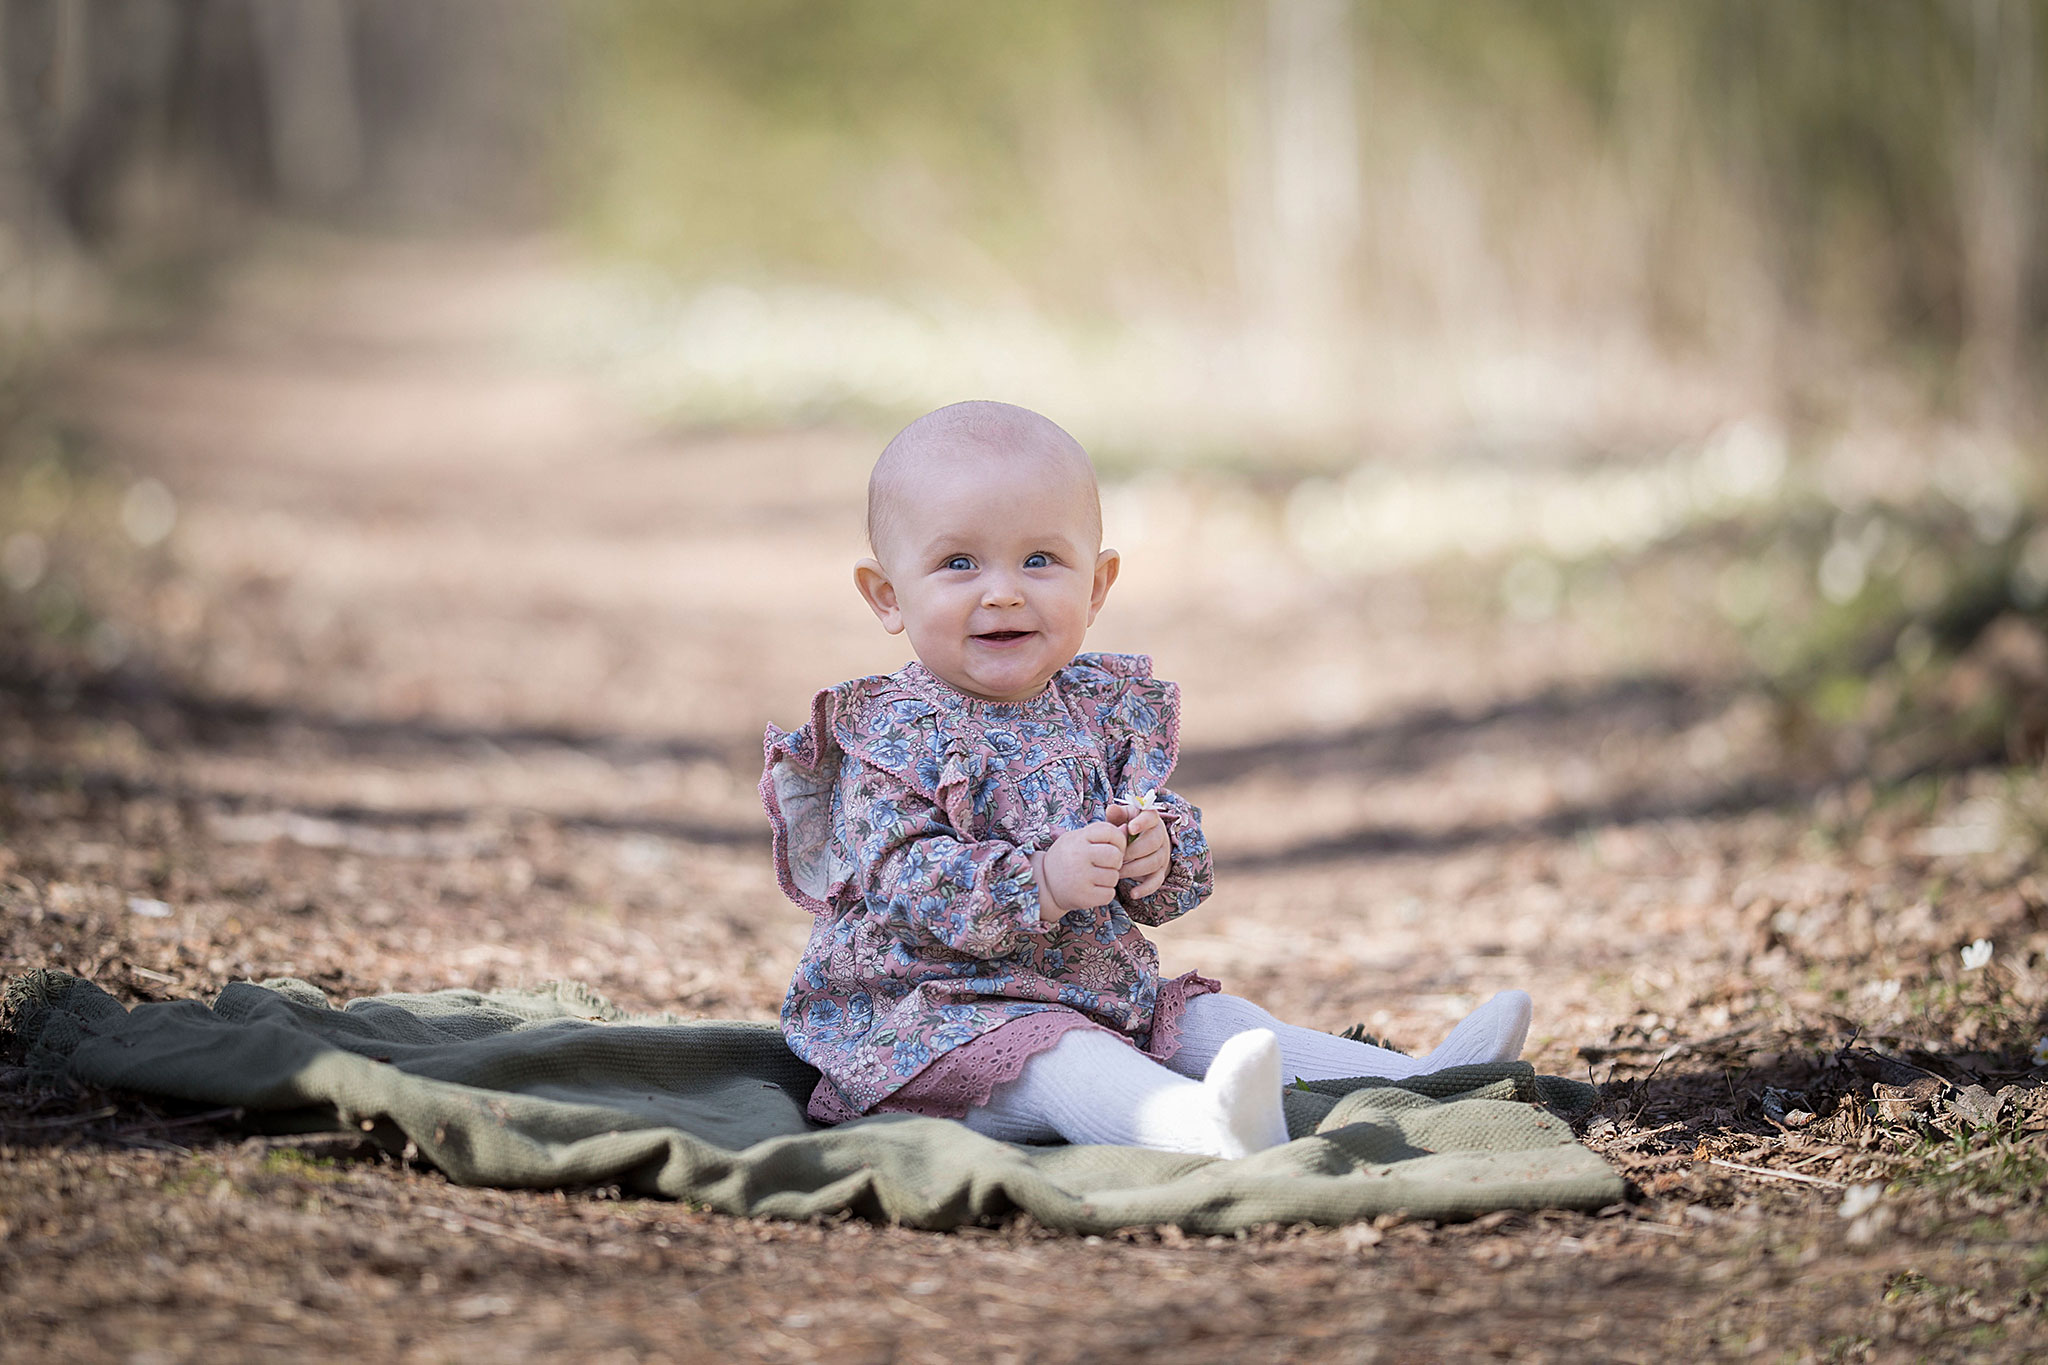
[6,970,1622,1232]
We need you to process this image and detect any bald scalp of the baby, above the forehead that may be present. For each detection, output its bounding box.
[868,401,1102,557]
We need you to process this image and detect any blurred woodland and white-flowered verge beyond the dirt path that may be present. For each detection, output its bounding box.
[0,0,2048,772]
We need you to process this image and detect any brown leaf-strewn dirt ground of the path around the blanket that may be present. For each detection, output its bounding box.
[0,244,2048,1363]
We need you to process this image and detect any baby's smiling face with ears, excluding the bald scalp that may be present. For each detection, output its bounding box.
[856,454,1116,702]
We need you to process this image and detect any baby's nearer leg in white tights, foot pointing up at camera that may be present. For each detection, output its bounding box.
[965,1029,1286,1156]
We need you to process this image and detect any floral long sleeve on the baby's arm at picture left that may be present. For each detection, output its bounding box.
[840,755,1053,958]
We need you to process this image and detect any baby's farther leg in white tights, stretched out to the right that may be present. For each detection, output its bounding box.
[1167,990,1530,1081]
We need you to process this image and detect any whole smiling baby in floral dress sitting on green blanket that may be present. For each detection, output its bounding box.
[762,403,1530,1156]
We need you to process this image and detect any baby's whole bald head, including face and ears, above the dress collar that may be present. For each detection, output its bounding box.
[854,403,1118,702]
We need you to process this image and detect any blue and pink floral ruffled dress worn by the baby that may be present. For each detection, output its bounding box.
[762,655,1219,1121]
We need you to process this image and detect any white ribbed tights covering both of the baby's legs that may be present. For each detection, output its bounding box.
[965,990,1530,1156]
